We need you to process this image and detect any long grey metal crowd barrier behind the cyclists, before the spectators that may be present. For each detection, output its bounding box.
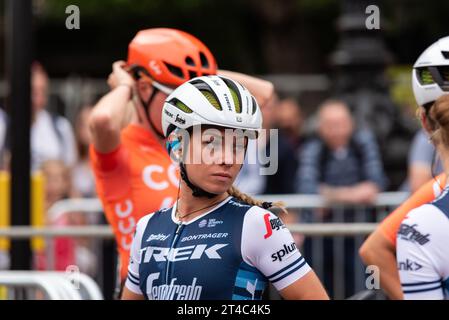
[0,192,408,299]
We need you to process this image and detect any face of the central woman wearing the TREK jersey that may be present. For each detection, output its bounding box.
[184,127,247,194]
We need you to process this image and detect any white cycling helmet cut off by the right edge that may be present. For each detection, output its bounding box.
[412,36,449,106]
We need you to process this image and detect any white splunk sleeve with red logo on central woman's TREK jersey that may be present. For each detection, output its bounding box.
[241,207,311,291]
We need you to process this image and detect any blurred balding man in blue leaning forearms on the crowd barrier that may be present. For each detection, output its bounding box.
[297,100,386,296]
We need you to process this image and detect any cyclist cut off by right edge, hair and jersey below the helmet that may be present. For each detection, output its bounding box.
[396,94,449,299]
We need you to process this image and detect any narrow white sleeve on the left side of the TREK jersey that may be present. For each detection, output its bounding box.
[125,214,153,294]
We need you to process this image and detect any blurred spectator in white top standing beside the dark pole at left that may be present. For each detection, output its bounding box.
[30,63,77,170]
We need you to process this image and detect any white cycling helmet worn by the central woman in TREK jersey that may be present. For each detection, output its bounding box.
[162,76,262,137]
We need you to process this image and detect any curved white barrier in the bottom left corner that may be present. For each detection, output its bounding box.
[0,271,103,300]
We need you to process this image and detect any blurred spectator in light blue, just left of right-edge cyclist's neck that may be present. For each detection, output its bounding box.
[401,129,443,193]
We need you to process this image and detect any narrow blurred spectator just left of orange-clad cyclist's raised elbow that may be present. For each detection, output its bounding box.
[72,105,96,198]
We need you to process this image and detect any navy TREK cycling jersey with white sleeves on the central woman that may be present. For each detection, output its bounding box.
[126,197,311,300]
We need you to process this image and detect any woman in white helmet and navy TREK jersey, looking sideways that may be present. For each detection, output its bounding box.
[122,76,328,300]
